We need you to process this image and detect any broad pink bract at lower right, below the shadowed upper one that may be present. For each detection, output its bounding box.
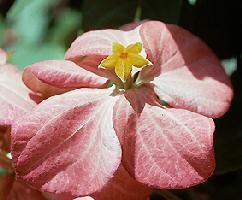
[114,86,215,188]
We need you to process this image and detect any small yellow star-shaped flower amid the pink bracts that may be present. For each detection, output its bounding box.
[101,42,149,82]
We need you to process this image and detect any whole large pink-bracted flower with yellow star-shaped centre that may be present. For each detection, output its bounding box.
[12,21,233,199]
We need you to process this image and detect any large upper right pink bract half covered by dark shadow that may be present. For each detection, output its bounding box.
[140,21,233,118]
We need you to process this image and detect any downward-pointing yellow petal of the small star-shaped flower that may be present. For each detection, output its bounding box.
[115,59,132,82]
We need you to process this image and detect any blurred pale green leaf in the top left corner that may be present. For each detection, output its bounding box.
[7,0,59,43]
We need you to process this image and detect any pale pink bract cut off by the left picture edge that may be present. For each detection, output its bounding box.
[0,65,35,126]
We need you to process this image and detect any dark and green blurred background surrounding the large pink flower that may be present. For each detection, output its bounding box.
[0,0,242,200]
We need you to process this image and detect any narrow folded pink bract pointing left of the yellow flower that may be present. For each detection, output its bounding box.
[23,60,107,93]
